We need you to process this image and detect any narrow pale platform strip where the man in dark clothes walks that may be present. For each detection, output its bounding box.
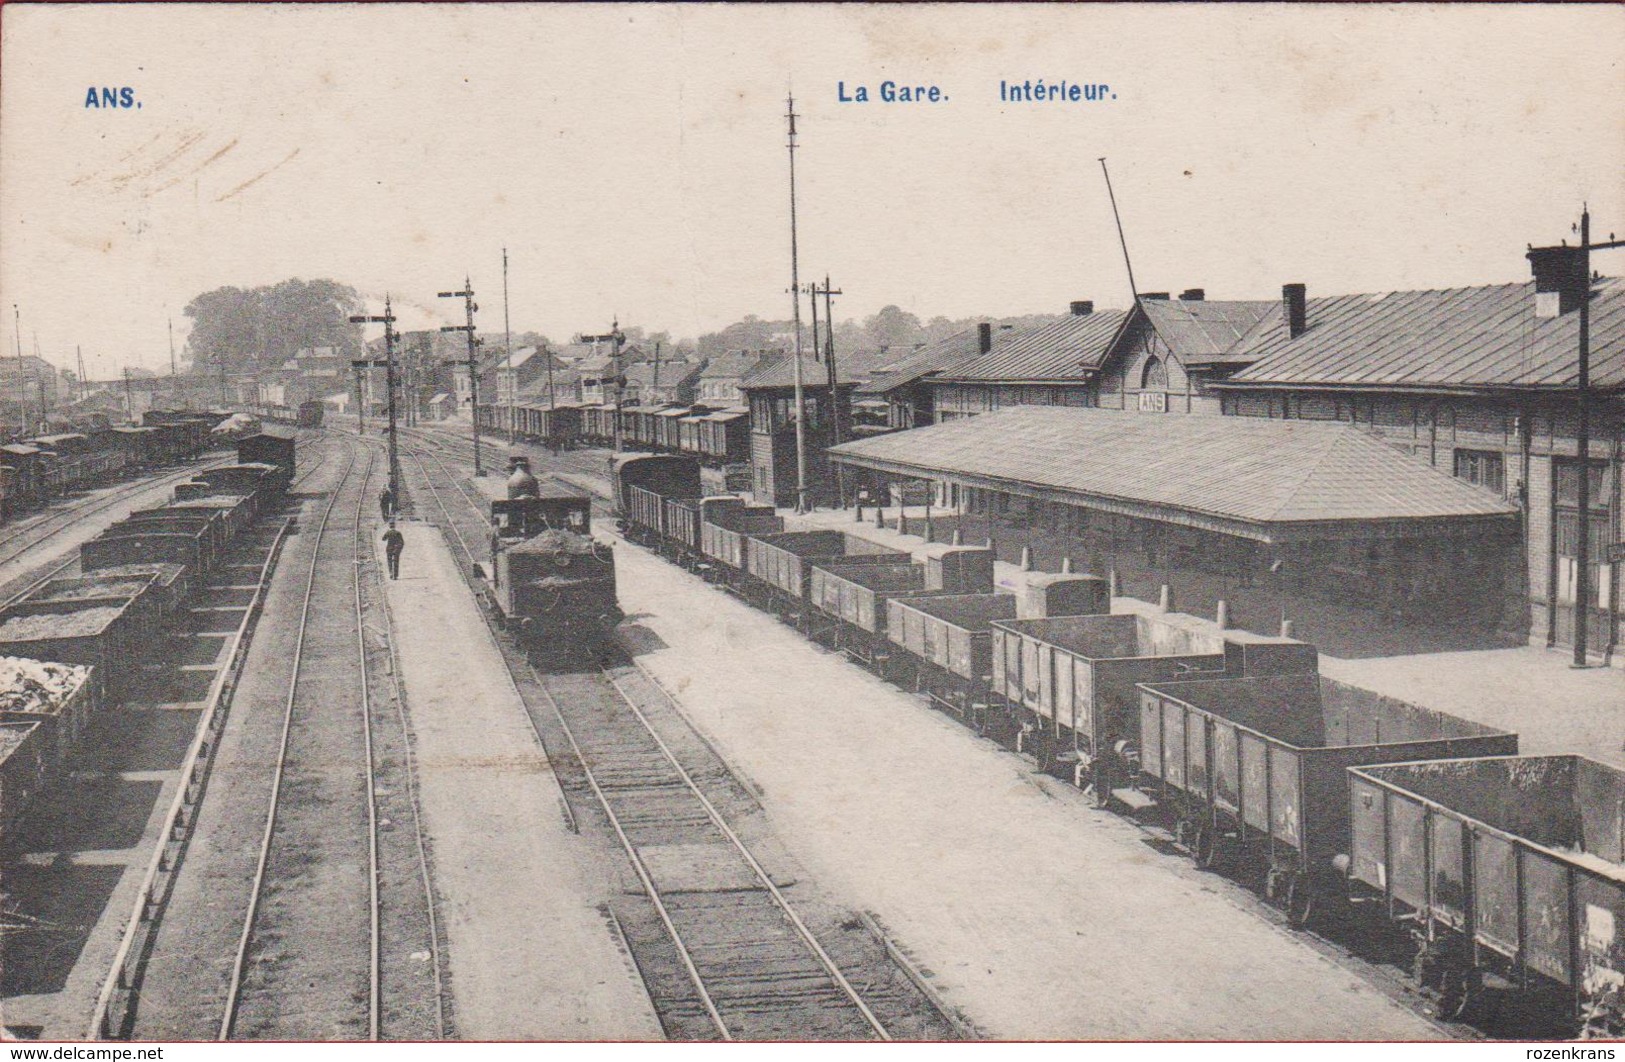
[379,521,661,1041]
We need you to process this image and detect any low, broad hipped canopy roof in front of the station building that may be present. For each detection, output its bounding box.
[829,406,1518,542]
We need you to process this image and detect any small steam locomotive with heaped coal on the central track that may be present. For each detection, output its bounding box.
[473,455,621,661]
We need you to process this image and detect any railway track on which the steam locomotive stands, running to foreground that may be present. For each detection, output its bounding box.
[396,438,954,1041]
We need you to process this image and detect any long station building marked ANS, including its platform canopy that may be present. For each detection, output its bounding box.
[837,259,1625,654]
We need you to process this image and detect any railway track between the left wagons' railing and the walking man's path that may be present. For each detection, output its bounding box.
[218,447,445,1041]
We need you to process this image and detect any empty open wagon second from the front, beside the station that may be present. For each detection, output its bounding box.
[1139,674,1518,926]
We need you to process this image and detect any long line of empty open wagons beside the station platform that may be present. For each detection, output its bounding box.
[614,455,1625,1036]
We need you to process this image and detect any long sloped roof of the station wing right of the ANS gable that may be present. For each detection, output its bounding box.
[1232,278,1625,388]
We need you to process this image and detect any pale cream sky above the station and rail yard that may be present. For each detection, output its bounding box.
[0,3,1625,377]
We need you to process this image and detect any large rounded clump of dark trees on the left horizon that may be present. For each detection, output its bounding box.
[185,278,362,372]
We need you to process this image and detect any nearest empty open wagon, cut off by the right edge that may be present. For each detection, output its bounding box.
[1349,755,1625,1036]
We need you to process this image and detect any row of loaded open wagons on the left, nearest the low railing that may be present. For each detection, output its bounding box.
[0,440,296,830]
